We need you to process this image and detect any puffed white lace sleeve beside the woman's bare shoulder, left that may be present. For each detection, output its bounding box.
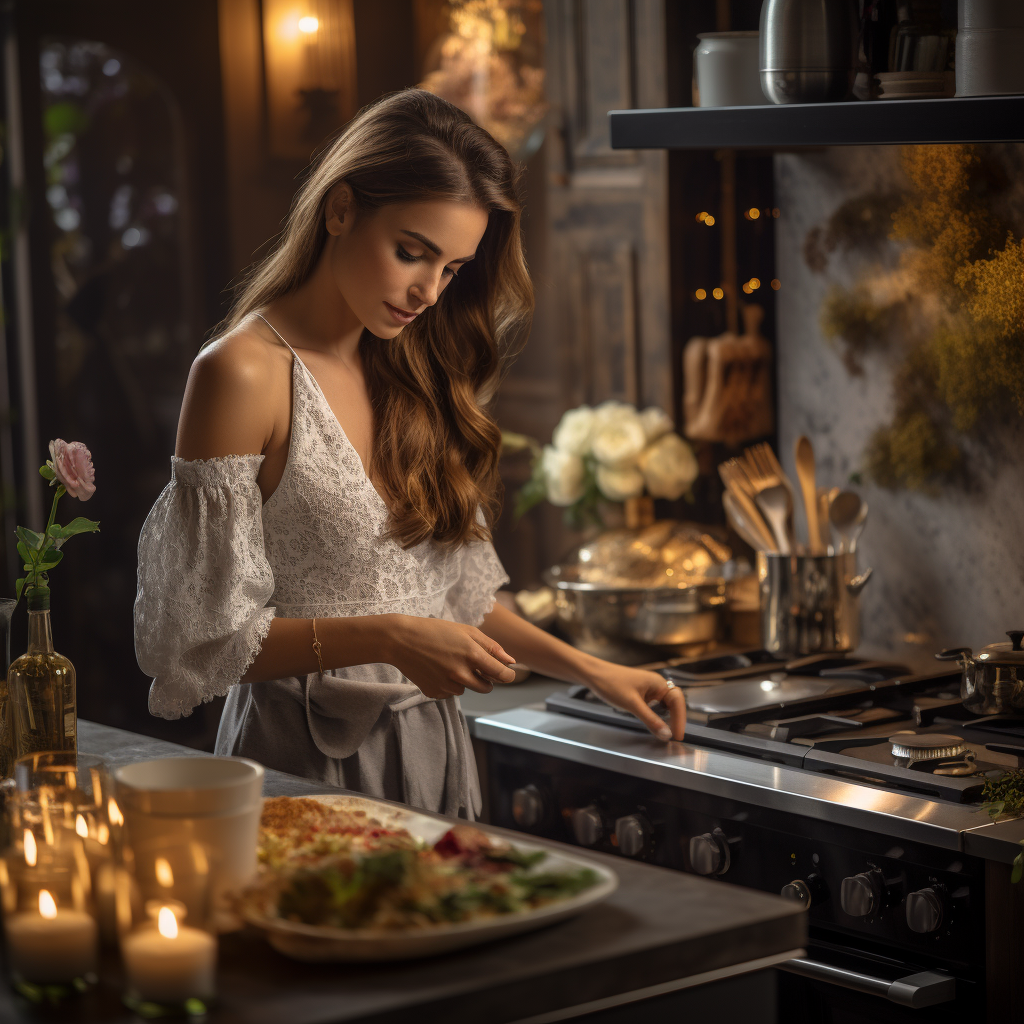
[135,455,274,718]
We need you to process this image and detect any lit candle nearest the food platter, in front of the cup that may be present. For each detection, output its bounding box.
[121,906,217,1004]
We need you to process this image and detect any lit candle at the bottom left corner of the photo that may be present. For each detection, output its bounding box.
[5,889,96,982]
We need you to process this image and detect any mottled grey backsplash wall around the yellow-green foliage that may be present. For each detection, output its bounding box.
[775,146,1024,667]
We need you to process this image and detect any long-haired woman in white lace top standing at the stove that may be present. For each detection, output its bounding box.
[135,90,685,818]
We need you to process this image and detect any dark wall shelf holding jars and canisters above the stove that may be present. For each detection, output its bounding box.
[608,96,1024,150]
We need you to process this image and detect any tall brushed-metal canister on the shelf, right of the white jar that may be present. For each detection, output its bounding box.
[760,0,857,103]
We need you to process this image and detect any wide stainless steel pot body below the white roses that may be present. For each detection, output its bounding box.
[544,565,726,665]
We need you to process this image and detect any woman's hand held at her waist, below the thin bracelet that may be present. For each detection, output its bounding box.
[388,615,515,700]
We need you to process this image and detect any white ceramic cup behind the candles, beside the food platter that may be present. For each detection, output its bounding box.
[114,757,263,927]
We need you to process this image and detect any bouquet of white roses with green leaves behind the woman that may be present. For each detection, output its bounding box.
[504,401,697,526]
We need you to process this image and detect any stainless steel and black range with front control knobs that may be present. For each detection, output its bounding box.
[474,651,1024,1022]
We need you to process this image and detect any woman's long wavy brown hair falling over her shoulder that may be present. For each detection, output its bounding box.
[222,89,534,548]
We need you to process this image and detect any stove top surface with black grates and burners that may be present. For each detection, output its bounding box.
[547,651,1024,803]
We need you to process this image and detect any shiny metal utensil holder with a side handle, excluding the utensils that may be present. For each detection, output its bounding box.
[758,551,871,654]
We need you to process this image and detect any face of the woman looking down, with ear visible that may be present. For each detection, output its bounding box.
[327,185,487,338]
